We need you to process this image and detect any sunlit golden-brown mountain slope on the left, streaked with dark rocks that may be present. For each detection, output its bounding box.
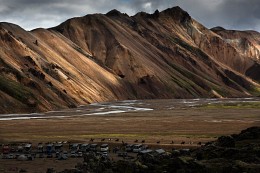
[0,24,133,112]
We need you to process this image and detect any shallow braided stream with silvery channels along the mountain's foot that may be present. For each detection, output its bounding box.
[0,98,260,121]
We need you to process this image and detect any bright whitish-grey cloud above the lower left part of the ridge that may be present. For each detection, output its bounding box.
[0,0,121,29]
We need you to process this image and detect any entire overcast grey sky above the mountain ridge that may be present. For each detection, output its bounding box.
[0,0,260,31]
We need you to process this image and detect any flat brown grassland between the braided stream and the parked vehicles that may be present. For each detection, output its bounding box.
[0,102,260,145]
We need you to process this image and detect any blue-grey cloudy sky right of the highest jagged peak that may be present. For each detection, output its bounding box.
[176,0,260,31]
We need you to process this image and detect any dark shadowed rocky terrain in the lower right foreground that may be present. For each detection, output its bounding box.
[47,127,260,173]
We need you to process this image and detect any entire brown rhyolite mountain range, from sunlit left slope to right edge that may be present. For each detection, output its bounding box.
[0,7,260,113]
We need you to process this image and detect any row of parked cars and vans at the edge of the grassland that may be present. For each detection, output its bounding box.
[2,143,154,160]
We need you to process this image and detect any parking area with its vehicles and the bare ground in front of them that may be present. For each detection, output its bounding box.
[0,141,165,173]
